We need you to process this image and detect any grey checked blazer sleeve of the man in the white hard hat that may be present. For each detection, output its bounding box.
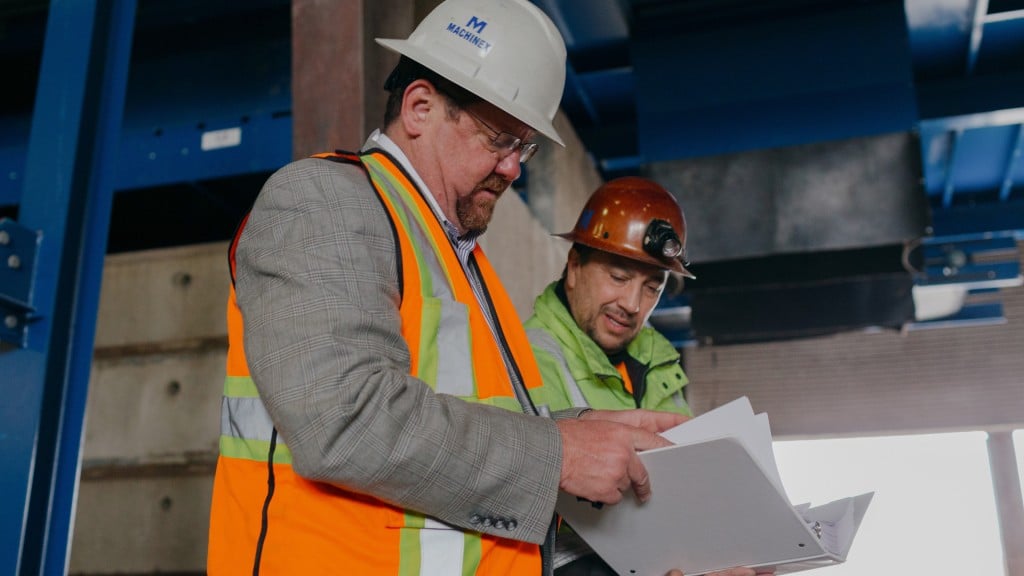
[236,159,561,543]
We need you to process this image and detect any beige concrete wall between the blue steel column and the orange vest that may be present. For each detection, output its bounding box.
[70,243,228,574]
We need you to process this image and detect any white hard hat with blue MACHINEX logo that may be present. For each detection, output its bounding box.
[377,0,565,146]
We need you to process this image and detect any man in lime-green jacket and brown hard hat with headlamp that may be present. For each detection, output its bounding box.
[525,176,771,576]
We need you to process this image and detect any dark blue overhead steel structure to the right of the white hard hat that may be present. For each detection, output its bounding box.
[537,0,1024,343]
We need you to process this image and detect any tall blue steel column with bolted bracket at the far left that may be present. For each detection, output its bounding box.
[0,0,136,575]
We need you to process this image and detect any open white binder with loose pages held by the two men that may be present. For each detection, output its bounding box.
[556,397,873,576]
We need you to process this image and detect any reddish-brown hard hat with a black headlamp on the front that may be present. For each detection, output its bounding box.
[557,176,696,278]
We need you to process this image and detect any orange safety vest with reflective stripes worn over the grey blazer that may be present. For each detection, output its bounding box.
[207,152,542,576]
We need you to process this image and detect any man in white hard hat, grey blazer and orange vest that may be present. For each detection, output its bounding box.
[208,0,761,576]
